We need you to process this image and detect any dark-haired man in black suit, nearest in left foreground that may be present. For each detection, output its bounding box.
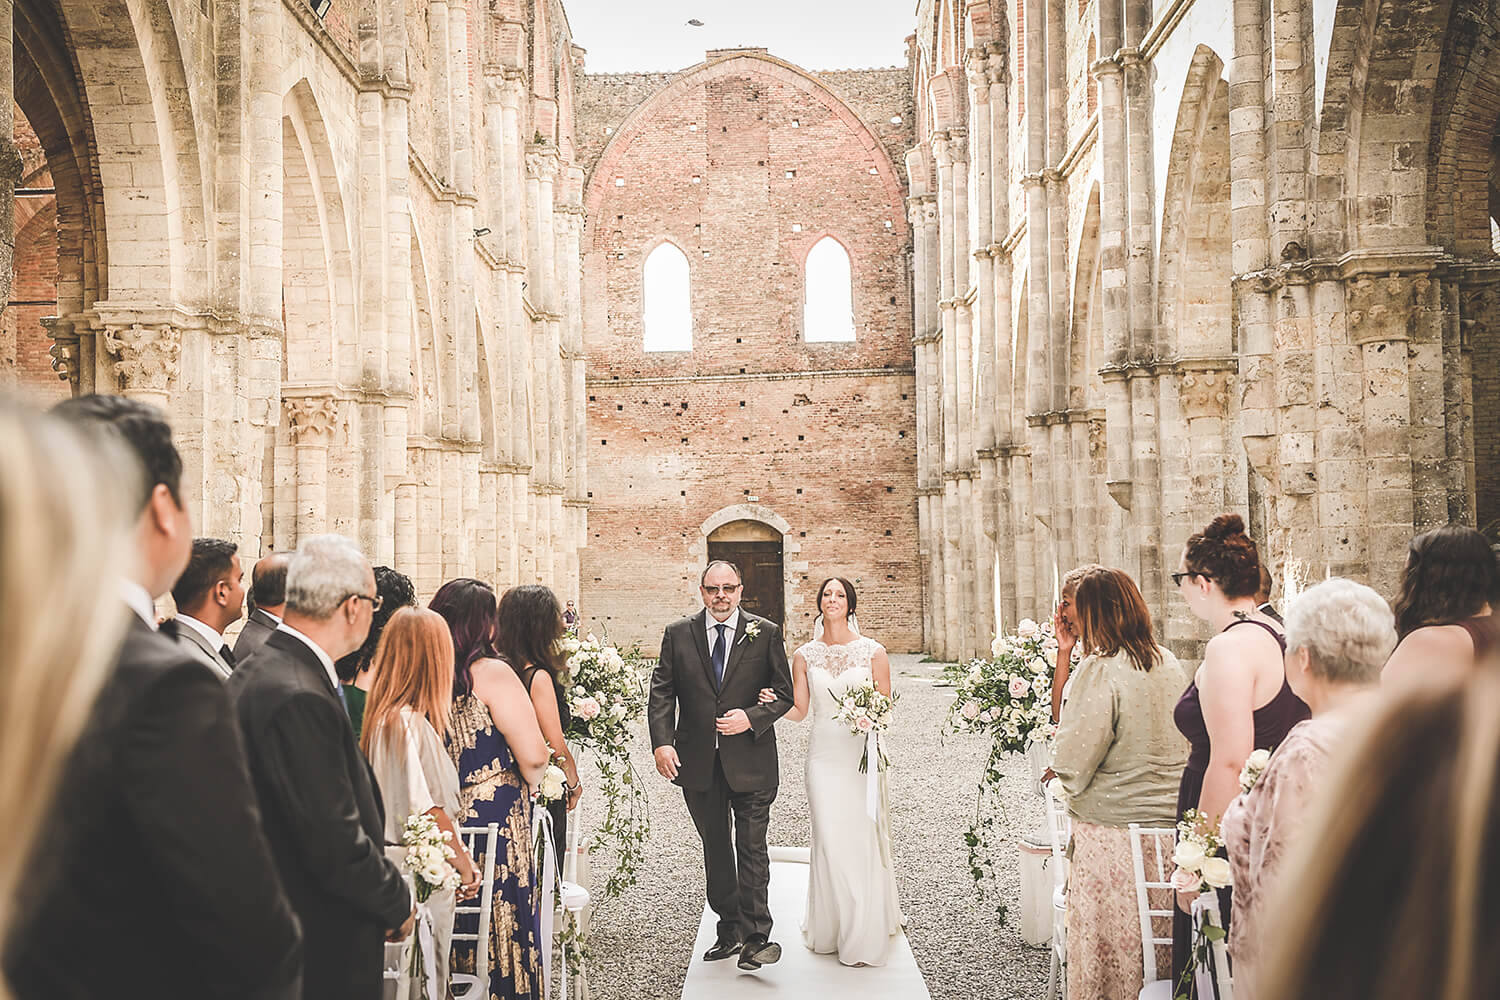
[5,396,302,1000]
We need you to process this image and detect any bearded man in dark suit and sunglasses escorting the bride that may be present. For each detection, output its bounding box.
[648,561,792,970]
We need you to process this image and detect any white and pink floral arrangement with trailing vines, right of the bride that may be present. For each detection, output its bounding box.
[944,618,1058,921]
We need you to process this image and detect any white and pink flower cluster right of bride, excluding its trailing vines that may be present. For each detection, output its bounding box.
[945,618,1058,753]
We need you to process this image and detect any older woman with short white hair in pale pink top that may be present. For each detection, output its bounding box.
[1223,577,1397,997]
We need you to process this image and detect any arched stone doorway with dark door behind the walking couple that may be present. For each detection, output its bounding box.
[693,504,807,633]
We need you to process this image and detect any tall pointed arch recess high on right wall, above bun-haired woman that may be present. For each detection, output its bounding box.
[1158,45,1235,357]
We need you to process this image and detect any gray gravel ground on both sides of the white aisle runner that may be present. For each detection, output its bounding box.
[567,655,1047,1000]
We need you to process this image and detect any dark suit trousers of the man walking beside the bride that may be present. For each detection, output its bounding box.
[683,751,777,942]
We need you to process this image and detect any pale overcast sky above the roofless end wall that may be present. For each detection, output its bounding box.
[563,0,917,73]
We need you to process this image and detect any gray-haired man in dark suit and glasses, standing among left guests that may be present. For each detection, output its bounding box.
[228,535,416,1000]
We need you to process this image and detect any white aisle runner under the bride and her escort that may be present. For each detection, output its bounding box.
[683,847,930,1000]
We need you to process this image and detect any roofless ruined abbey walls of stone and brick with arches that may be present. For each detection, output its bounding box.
[0,0,1500,658]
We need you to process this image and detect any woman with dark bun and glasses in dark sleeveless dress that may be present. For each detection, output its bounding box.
[1172,514,1311,982]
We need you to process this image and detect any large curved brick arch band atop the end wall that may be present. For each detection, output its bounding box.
[585,52,909,249]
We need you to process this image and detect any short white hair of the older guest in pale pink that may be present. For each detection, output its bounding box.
[1287,577,1397,684]
